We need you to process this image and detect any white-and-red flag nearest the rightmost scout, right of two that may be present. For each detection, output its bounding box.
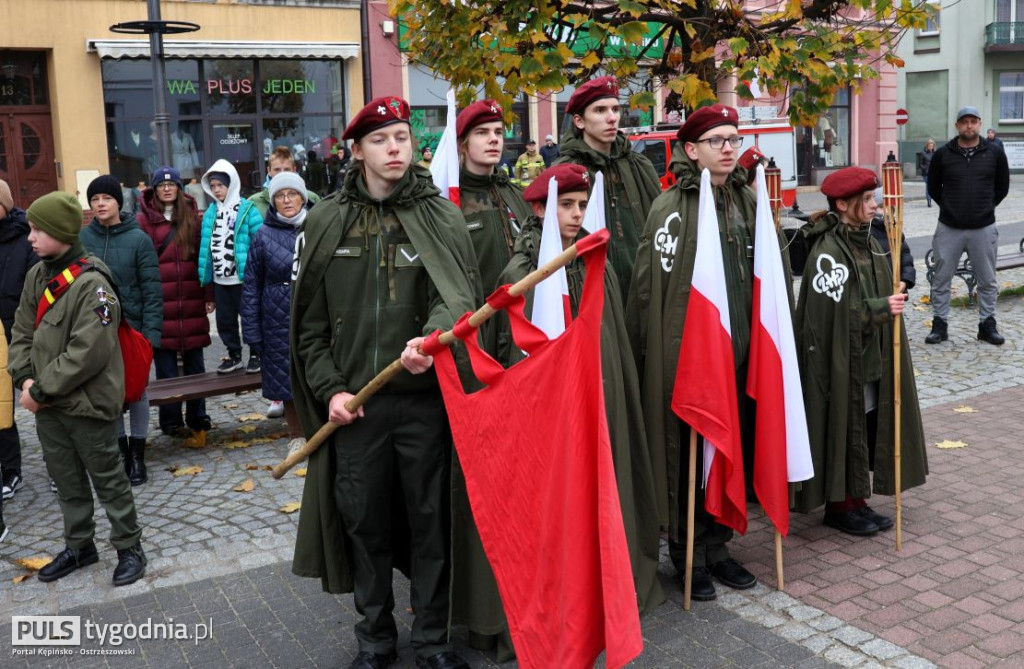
[746,165,814,537]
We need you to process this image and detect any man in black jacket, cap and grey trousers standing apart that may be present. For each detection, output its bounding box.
[925,107,1010,346]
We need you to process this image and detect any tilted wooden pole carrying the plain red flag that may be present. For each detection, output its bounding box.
[270,237,577,478]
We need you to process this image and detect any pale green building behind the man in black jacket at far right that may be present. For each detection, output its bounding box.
[899,0,1024,173]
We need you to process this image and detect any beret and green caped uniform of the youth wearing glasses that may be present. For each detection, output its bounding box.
[627,104,757,600]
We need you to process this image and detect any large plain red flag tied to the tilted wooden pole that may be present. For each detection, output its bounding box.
[423,231,643,669]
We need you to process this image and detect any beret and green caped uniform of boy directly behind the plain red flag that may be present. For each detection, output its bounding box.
[501,164,665,613]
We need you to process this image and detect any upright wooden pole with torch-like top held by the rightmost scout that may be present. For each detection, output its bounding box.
[882,153,903,551]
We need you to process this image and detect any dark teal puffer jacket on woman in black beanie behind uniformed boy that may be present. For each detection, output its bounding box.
[79,212,164,348]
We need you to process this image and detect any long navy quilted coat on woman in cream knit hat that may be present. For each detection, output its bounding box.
[242,208,299,401]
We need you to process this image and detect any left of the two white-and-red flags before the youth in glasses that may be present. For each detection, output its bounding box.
[672,169,746,534]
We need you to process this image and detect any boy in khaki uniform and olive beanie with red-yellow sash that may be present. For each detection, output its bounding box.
[9,192,146,585]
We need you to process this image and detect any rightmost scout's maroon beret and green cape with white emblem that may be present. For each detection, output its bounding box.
[796,167,928,536]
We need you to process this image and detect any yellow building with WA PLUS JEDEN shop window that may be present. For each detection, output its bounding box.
[0,0,362,207]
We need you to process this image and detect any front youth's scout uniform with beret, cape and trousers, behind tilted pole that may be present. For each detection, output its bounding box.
[291,97,482,667]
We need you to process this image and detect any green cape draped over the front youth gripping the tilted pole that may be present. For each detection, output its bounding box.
[289,167,482,593]
